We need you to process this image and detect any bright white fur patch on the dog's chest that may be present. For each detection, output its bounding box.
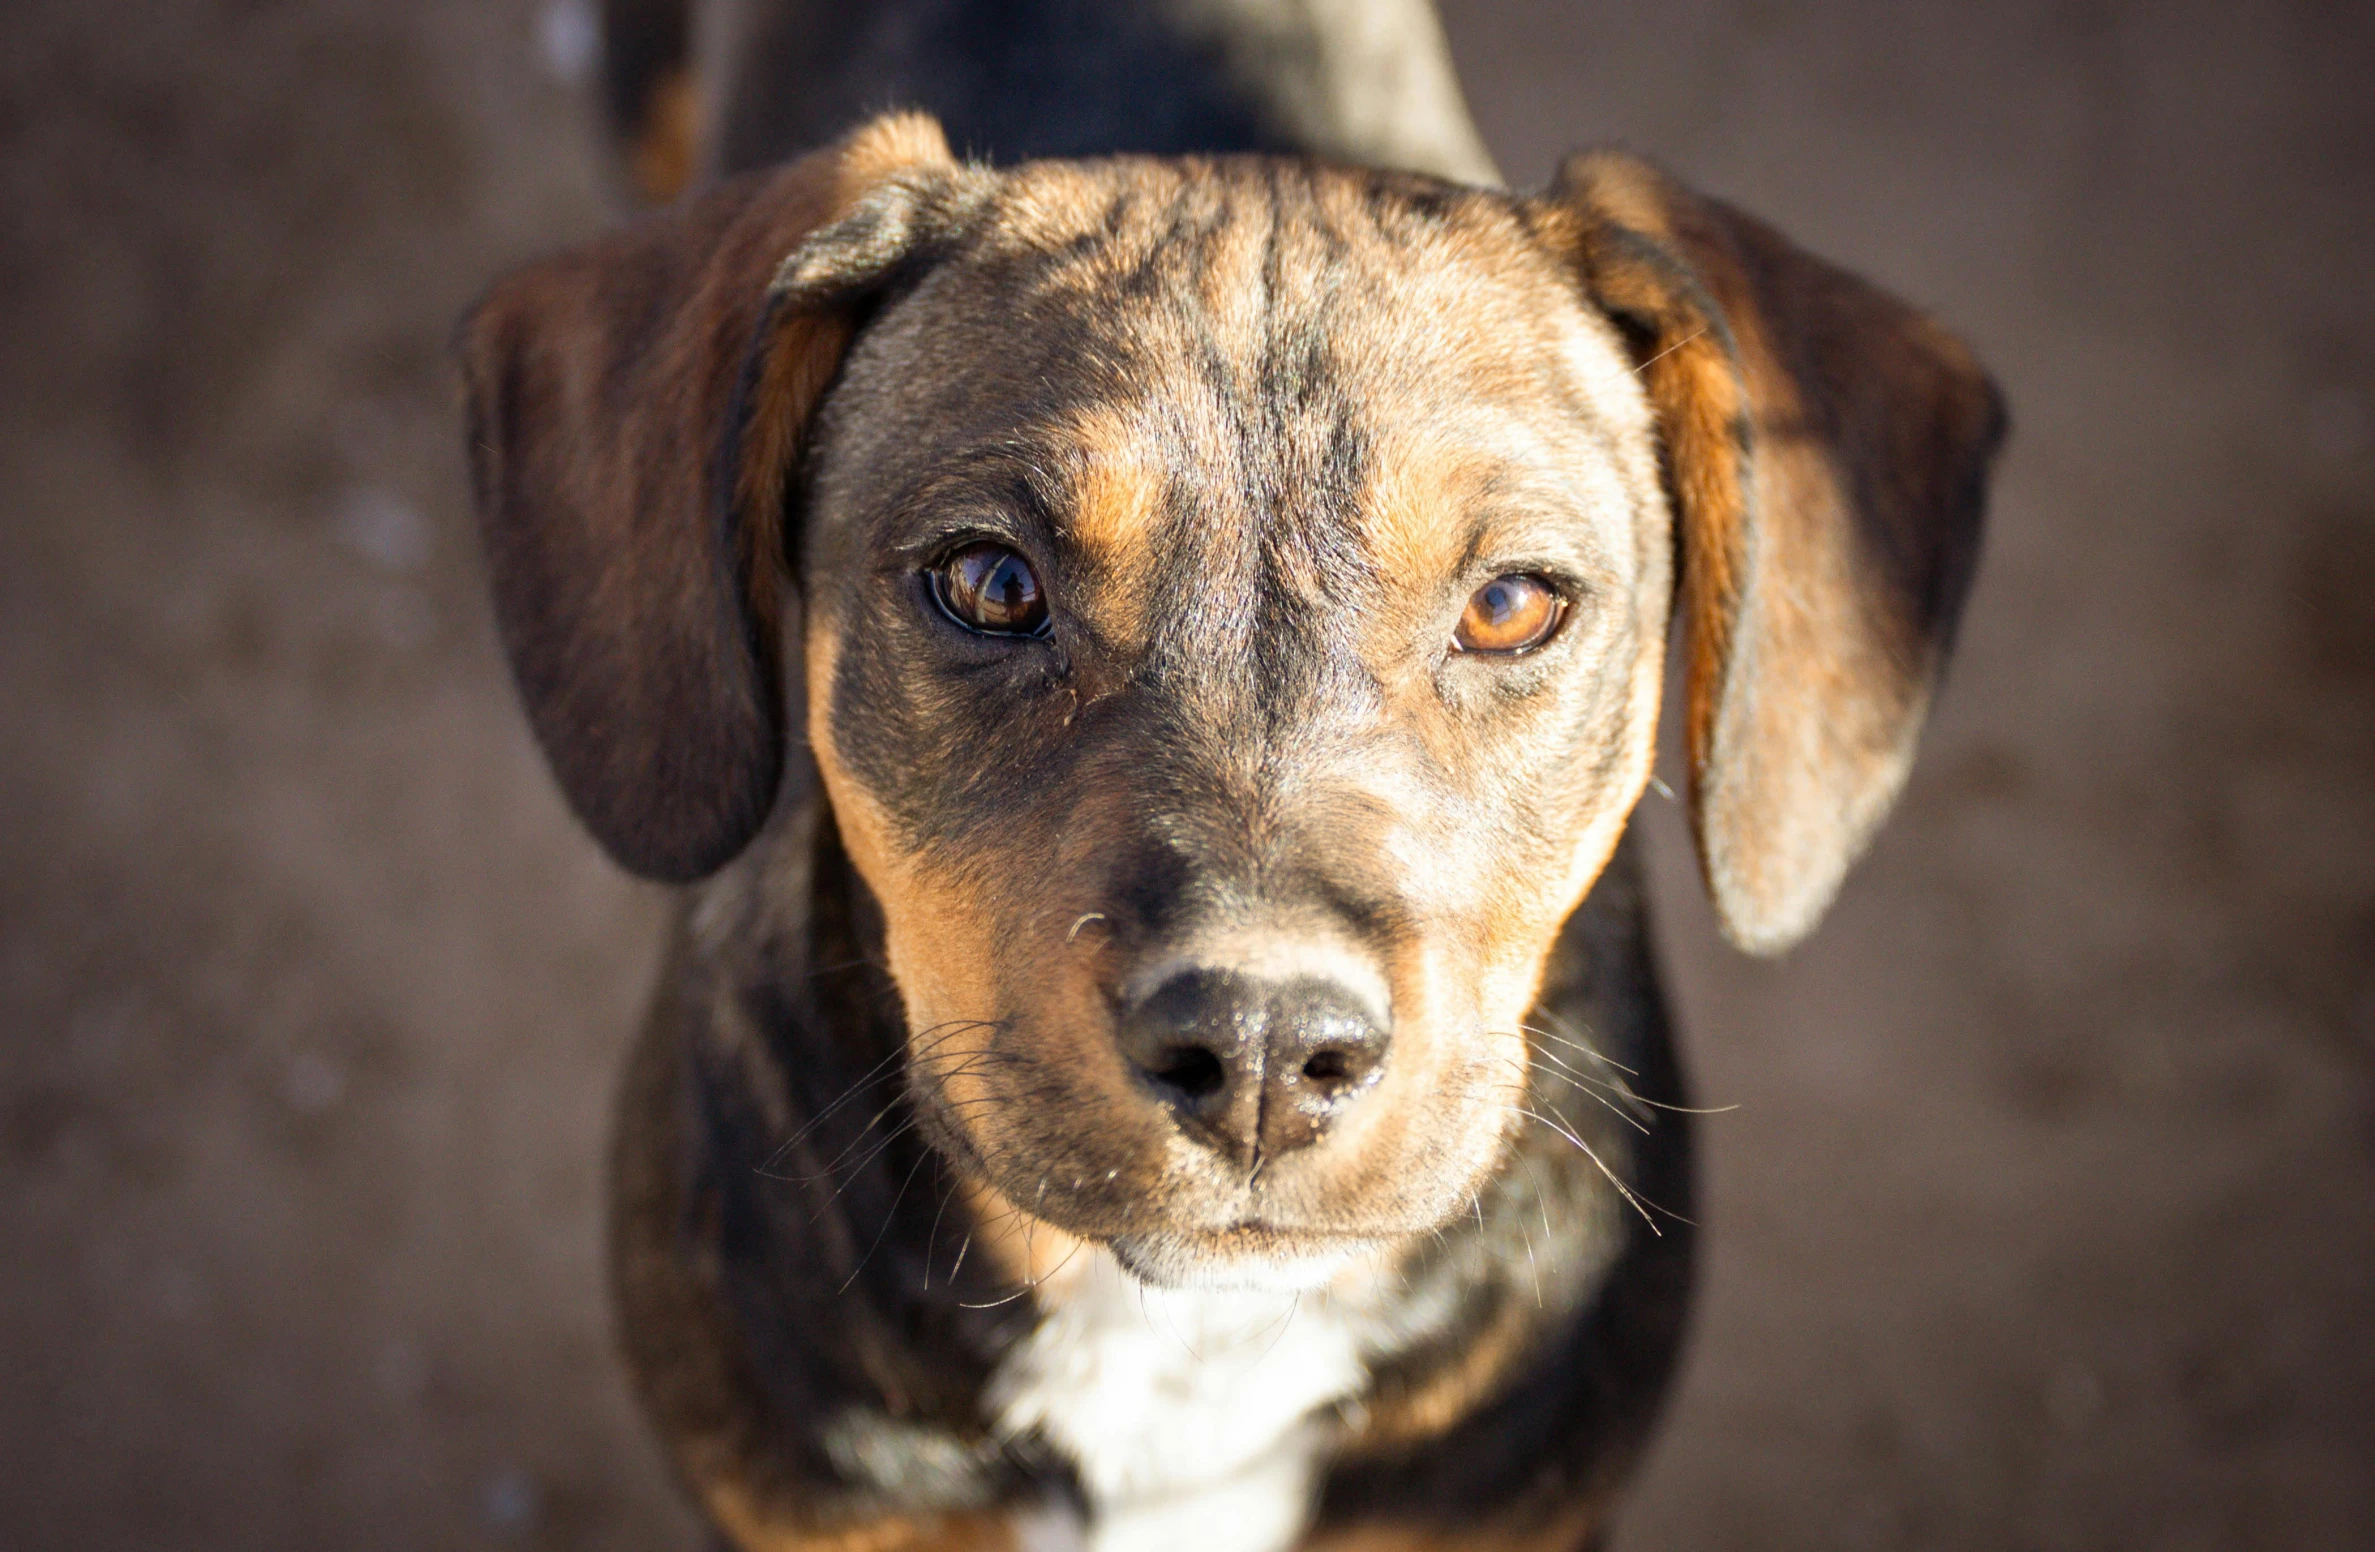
[988,1248,1366,1552]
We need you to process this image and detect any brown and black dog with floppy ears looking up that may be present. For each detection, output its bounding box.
[461,0,2005,1552]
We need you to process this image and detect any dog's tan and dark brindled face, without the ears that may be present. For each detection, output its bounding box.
[800,162,1672,1276]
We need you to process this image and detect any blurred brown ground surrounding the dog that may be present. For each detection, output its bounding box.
[0,0,2375,1552]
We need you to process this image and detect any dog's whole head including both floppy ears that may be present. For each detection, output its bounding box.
[463,116,2002,1281]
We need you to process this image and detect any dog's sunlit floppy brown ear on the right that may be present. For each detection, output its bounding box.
[1534,152,2005,953]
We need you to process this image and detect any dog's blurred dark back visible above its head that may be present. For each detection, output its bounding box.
[696,0,1499,183]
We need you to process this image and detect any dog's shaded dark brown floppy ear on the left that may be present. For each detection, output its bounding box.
[458,116,976,882]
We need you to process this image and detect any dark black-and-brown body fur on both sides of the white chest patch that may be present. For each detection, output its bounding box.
[610,803,1693,1547]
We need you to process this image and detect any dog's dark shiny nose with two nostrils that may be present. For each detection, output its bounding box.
[1121,967,1387,1167]
